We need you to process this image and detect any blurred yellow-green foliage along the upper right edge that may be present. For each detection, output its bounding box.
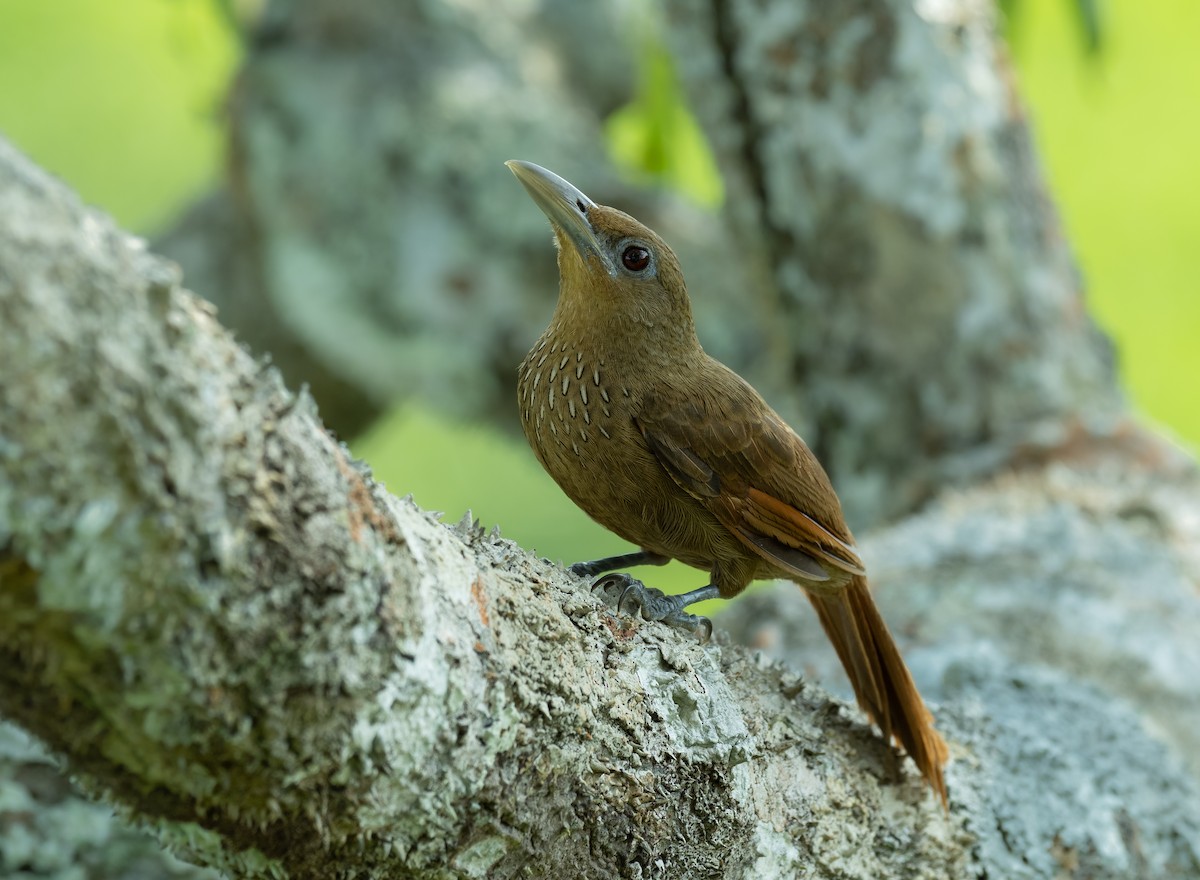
[1014,0,1200,447]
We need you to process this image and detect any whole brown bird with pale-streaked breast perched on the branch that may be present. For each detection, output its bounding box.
[506,161,948,804]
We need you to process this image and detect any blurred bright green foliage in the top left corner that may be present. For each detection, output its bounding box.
[0,0,236,231]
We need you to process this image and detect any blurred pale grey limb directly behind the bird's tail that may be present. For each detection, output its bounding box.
[721,449,1200,778]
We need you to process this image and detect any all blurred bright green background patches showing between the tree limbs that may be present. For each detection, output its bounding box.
[0,0,1200,597]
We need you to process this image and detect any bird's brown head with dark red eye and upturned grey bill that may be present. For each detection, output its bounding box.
[505,160,698,349]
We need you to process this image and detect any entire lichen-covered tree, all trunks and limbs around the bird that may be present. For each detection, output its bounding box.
[7,0,1200,878]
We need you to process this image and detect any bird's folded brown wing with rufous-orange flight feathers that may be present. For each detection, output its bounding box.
[635,371,864,581]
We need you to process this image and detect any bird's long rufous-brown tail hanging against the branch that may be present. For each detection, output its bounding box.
[805,576,949,806]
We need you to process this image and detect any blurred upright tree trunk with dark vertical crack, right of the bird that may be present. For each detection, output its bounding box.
[667,0,1121,523]
